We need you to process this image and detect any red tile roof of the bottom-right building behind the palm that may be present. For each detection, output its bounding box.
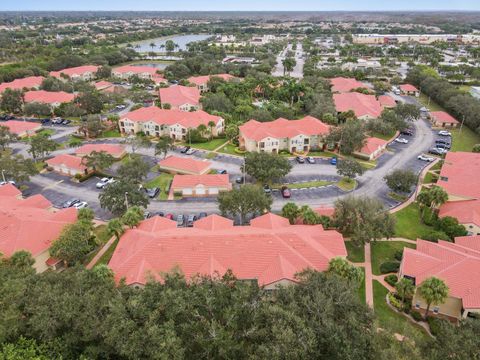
[401,239,480,309]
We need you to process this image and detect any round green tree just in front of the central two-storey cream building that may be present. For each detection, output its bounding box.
[245,152,292,184]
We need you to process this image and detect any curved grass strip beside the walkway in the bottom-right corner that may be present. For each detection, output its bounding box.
[373,280,429,344]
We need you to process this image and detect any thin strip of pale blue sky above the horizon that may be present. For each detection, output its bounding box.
[0,0,480,11]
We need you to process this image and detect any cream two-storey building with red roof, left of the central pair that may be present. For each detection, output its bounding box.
[118,106,225,140]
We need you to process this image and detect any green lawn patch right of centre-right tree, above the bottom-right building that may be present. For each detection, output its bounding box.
[393,203,432,240]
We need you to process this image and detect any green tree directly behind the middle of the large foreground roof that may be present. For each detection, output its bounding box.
[217,185,273,224]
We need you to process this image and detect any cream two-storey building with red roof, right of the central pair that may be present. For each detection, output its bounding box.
[239,116,330,153]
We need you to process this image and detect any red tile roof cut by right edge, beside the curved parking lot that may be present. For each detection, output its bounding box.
[437,152,480,199]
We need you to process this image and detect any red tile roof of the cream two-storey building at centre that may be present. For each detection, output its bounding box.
[240,116,330,141]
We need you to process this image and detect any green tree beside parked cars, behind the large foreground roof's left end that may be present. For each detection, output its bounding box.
[98,177,148,216]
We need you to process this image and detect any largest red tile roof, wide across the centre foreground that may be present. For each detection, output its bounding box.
[109,214,347,285]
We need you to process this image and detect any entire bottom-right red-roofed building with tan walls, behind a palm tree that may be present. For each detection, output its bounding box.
[399,236,480,319]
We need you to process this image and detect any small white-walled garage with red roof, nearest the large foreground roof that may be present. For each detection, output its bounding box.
[170,174,232,197]
